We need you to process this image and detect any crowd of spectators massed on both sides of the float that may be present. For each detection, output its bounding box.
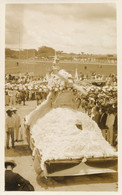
[5,73,117,145]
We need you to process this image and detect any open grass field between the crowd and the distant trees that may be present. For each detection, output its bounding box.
[5,59,117,76]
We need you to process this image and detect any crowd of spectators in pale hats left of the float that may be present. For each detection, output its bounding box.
[5,74,47,106]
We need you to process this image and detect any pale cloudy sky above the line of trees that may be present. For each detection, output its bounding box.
[5,3,117,54]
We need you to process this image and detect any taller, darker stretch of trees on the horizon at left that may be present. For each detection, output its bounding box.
[5,46,55,59]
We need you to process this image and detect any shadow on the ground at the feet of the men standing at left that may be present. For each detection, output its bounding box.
[5,145,32,157]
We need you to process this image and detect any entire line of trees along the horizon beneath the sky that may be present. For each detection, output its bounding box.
[5,46,117,61]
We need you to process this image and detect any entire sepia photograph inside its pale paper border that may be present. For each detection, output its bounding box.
[4,2,118,192]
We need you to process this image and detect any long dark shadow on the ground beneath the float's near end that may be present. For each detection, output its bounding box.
[36,173,118,191]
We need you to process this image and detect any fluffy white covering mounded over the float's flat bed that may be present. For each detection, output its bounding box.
[31,108,117,170]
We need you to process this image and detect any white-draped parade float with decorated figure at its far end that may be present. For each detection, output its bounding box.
[25,64,117,178]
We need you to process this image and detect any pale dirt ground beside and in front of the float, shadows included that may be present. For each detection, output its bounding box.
[5,101,118,191]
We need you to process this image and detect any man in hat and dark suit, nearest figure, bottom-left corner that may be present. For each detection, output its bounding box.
[5,160,34,191]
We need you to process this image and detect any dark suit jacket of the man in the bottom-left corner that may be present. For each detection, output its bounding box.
[5,170,33,191]
